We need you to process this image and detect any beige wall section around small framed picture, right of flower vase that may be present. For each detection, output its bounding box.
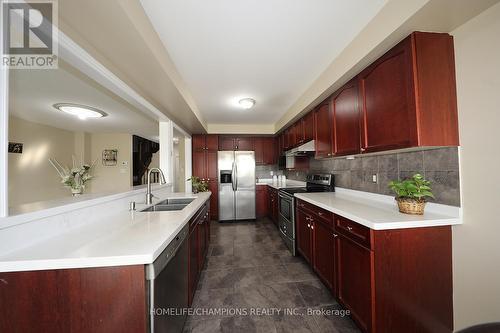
[88,133,132,193]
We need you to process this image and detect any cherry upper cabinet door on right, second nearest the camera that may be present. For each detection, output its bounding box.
[332,80,360,155]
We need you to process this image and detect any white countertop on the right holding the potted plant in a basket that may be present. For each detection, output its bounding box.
[295,188,462,230]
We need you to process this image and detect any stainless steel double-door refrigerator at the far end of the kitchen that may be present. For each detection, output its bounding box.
[217,151,255,221]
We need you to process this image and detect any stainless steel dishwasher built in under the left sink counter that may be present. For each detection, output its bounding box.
[146,224,189,333]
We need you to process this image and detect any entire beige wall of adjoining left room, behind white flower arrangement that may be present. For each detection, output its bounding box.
[8,116,134,207]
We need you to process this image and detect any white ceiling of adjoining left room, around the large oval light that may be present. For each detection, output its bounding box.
[9,60,159,140]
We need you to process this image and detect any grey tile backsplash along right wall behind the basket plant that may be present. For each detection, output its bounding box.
[285,147,460,206]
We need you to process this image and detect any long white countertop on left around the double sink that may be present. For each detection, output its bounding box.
[0,192,210,272]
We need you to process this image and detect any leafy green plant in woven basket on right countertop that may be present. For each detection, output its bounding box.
[389,173,434,215]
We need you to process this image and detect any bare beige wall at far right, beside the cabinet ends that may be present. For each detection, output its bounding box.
[452,4,500,330]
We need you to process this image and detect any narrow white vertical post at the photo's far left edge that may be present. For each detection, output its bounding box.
[0,3,9,217]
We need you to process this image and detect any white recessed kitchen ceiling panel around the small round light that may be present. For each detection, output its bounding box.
[141,0,385,124]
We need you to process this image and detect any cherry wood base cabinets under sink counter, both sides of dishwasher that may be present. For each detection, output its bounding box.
[0,201,210,333]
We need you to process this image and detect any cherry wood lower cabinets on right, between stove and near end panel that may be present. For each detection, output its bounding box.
[295,200,453,333]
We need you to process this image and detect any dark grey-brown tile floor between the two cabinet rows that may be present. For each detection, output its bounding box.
[184,219,359,333]
